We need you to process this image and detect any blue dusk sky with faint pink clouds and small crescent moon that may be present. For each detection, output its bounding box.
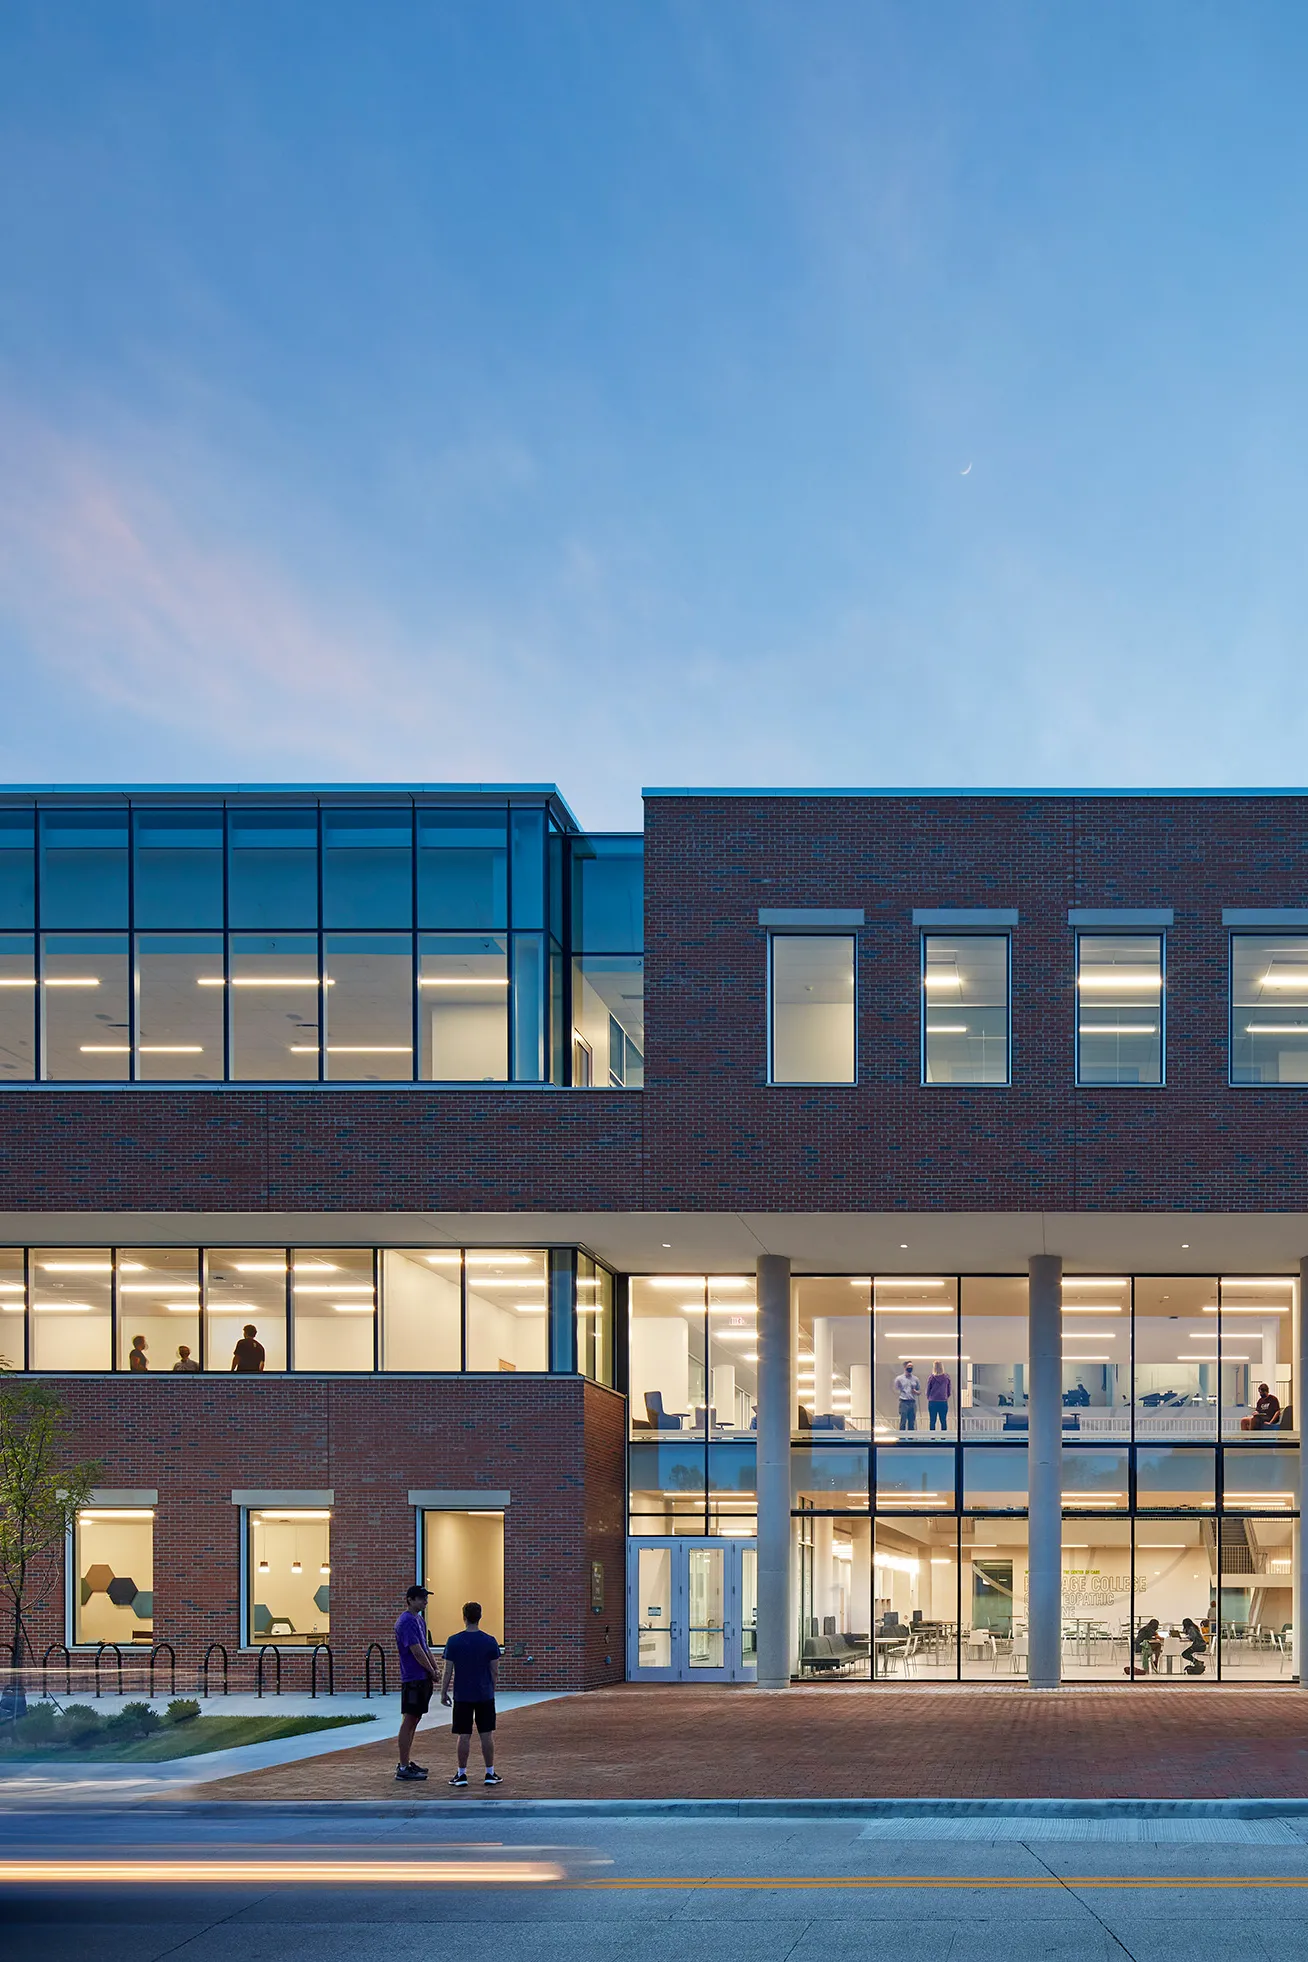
[0,0,1308,824]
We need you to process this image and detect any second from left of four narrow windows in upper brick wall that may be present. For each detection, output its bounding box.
[922,934,1008,1083]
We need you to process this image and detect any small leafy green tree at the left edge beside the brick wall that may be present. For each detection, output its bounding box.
[0,1379,102,1717]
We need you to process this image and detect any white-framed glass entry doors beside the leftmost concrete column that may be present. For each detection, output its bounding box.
[628,1540,759,1683]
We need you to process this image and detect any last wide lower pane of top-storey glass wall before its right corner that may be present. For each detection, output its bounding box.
[418,934,508,1083]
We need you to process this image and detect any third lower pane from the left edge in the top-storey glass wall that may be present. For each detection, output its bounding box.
[135,934,224,1083]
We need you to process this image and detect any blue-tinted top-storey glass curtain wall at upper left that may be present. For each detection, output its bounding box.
[0,802,619,1087]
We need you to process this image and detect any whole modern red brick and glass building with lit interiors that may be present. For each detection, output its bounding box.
[0,785,1308,1687]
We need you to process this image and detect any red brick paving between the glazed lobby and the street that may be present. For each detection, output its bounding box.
[192,1683,1308,1803]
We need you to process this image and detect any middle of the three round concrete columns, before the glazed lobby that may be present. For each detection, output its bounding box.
[1028,1254,1063,1689]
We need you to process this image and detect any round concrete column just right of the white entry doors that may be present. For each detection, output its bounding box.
[757,1254,794,1689]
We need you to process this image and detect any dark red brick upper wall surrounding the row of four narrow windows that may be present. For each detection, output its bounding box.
[645,797,1308,1213]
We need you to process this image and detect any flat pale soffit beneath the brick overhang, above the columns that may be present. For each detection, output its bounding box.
[0,1213,1308,1275]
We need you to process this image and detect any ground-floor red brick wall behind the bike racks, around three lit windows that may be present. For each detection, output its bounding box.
[21,1375,626,1689]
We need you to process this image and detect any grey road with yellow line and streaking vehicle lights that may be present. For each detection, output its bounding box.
[0,1805,1308,1962]
